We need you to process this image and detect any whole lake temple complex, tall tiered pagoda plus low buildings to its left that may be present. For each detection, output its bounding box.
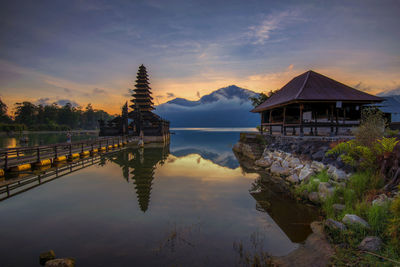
[100,65,169,142]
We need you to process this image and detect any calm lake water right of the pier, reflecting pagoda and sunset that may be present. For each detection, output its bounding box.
[0,130,315,266]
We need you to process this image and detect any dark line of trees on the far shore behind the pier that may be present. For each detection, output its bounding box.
[0,99,113,131]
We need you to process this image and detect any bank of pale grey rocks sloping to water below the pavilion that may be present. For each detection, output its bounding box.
[233,138,351,204]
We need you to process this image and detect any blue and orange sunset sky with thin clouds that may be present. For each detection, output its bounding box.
[0,0,400,114]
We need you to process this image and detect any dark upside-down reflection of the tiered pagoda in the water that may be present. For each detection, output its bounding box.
[109,144,169,212]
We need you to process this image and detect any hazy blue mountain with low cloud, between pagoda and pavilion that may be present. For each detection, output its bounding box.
[155,85,260,127]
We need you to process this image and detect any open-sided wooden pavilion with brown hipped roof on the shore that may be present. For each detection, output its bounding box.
[251,70,383,136]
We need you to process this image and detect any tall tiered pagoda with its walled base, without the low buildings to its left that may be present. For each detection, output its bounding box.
[128,64,169,141]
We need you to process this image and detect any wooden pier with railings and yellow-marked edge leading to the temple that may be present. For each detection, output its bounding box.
[0,136,137,173]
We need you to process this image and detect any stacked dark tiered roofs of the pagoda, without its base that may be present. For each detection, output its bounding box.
[130,64,155,113]
